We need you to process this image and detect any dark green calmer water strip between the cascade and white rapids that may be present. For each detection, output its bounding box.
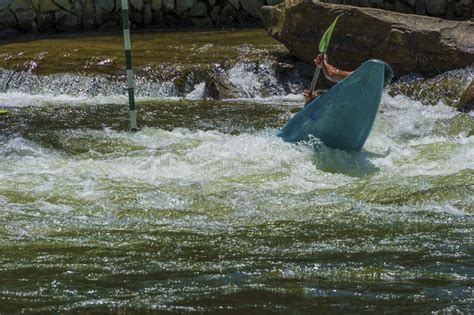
[0,99,291,154]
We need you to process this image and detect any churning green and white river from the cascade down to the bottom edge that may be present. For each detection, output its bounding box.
[0,29,474,314]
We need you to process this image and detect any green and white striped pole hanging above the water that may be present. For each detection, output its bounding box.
[122,0,137,131]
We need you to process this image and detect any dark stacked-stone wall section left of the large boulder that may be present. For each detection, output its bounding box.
[0,0,283,33]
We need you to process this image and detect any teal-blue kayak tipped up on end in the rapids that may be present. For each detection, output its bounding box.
[279,59,391,151]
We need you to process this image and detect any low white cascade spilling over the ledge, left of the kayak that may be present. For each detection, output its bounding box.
[0,52,308,99]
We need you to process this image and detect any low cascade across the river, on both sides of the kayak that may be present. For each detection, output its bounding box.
[0,45,474,106]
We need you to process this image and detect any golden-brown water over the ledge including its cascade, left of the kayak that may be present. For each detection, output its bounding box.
[0,29,313,99]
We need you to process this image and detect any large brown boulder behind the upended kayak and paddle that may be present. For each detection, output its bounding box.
[261,0,474,76]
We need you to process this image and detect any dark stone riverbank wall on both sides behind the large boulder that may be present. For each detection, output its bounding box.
[0,0,474,34]
